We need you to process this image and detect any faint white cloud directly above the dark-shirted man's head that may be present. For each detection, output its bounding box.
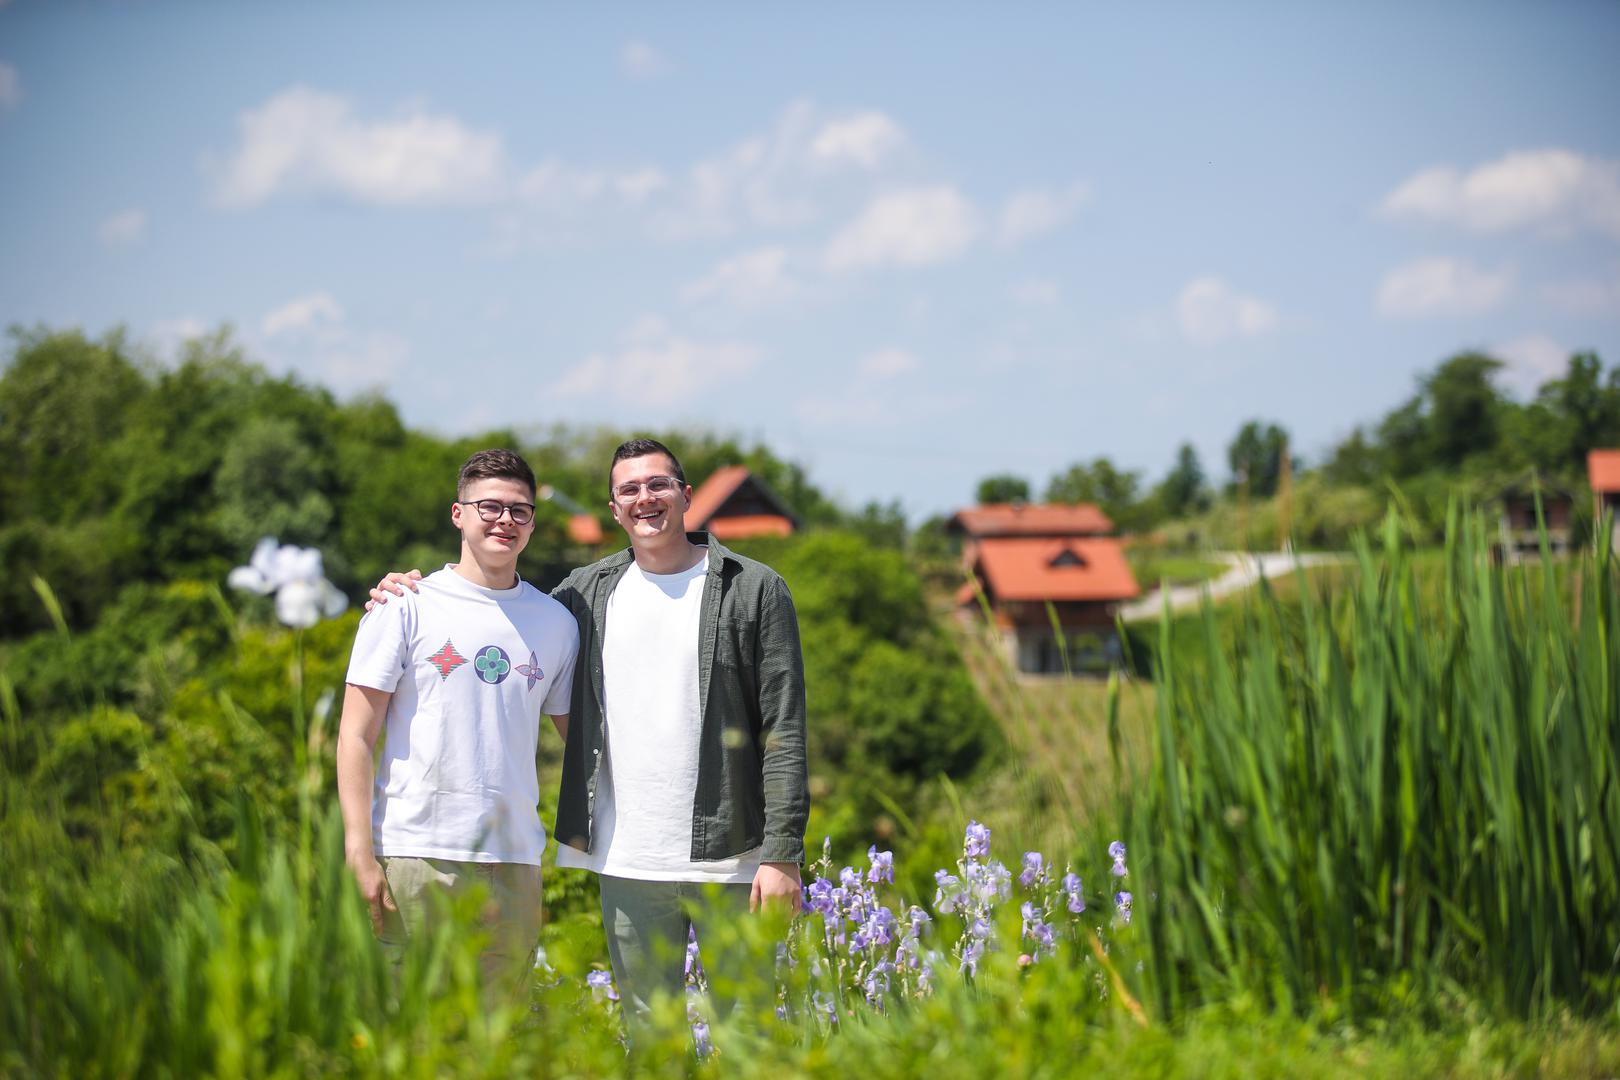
[557,319,760,408]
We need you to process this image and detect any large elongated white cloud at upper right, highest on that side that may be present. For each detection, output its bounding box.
[1379,149,1620,238]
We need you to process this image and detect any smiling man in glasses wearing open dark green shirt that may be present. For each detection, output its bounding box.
[371,439,810,1023]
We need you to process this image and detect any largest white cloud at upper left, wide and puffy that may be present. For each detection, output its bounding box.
[217,86,505,207]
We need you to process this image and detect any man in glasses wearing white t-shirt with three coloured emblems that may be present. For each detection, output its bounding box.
[337,450,580,986]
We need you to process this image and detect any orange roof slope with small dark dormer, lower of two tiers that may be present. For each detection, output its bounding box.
[978,538,1142,601]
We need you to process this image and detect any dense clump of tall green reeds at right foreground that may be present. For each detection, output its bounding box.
[1124,508,1620,1015]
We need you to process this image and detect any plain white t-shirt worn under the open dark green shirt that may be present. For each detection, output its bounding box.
[557,549,760,882]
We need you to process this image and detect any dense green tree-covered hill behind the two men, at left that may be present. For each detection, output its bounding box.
[0,329,906,638]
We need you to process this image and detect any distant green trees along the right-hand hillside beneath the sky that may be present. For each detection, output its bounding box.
[978,351,1620,546]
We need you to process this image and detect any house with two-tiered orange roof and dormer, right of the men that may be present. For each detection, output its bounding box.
[946,504,1142,675]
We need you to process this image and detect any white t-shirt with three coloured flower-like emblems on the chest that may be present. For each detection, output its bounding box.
[348,567,580,866]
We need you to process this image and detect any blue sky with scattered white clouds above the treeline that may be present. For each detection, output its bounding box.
[0,0,1620,517]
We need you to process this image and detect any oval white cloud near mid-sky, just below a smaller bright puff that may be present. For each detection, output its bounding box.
[826,186,978,270]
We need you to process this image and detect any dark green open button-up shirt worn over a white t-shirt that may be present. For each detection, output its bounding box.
[551,533,810,863]
